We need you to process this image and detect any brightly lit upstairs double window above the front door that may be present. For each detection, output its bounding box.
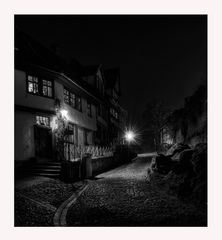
[27,75,53,98]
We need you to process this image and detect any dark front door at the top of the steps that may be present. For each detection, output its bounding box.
[34,126,52,158]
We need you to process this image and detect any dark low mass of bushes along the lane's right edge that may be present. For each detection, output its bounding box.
[148,143,207,205]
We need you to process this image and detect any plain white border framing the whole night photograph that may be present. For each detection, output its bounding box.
[0,0,222,240]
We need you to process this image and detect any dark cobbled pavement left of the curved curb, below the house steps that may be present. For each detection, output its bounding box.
[14,177,84,226]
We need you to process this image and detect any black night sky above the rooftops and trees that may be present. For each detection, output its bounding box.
[15,15,207,122]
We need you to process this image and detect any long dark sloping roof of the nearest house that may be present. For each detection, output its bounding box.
[15,28,106,101]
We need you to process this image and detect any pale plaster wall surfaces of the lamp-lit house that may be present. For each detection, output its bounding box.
[15,70,97,160]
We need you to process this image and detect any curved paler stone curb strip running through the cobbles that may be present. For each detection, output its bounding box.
[53,182,88,227]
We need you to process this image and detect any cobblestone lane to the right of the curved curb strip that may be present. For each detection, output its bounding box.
[67,157,206,226]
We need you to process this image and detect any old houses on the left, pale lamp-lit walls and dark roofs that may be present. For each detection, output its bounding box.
[14,30,126,161]
